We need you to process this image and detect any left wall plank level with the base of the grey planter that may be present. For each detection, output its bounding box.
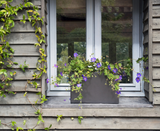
[0,93,40,105]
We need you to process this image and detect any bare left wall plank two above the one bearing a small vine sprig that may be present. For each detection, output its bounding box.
[7,33,37,44]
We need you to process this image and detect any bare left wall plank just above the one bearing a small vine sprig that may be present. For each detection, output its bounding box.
[11,45,40,56]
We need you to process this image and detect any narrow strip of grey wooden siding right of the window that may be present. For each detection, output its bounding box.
[152,0,160,105]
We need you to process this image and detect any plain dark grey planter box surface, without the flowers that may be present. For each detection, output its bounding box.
[71,73,119,104]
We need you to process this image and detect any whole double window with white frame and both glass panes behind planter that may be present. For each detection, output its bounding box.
[48,0,144,96]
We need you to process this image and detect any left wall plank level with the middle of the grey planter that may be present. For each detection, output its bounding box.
[3,81,41,92]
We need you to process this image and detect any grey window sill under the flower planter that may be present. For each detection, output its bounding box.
[42,96,153,109]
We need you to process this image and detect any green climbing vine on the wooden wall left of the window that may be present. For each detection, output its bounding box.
[0,0,51,131]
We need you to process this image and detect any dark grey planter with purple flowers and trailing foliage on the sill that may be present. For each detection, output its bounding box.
[52,53,141,104]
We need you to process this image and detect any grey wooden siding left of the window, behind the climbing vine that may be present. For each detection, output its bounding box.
[0,0,44,130]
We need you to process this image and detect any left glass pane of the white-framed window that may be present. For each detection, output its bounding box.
[57,0,86,83]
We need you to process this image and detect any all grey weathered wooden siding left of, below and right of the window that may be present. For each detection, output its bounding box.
[0,0,160,131]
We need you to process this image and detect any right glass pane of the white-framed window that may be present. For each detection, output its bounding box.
[102,0,133,83]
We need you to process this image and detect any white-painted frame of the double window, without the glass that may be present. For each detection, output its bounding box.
[47,0,145,96]
